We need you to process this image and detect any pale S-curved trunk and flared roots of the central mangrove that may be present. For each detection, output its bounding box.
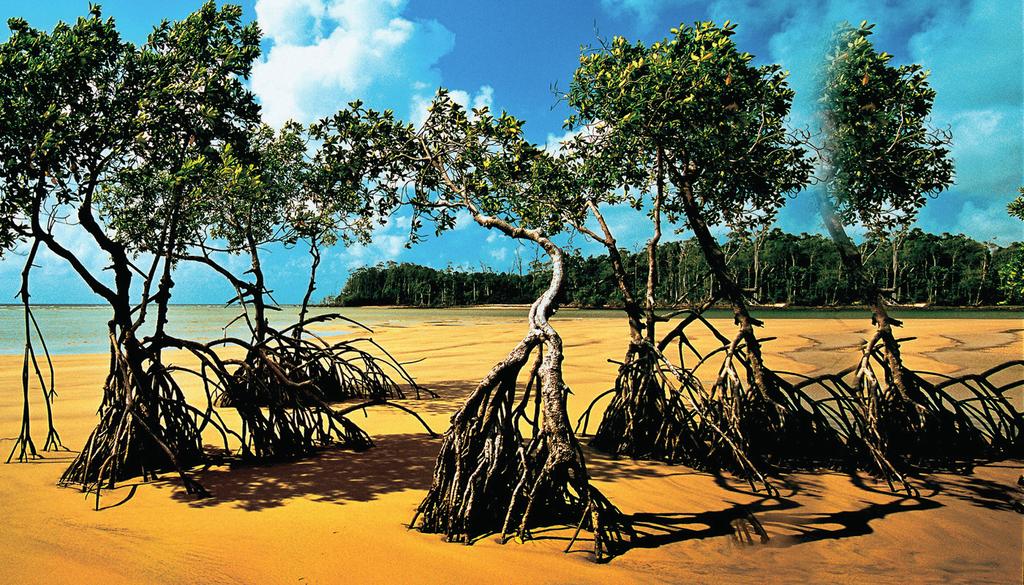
[412,214,620,558]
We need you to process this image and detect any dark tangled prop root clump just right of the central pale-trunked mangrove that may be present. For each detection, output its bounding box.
[581,311,842,494]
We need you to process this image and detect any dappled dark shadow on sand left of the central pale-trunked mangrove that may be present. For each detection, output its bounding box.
[164,433,440,511]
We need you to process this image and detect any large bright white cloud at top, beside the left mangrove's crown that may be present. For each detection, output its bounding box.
[252,0,455,125]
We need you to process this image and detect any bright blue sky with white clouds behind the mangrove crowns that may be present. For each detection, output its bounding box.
[0,0,1024,302]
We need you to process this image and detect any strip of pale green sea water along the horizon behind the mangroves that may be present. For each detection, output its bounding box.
[0,304,1024,354]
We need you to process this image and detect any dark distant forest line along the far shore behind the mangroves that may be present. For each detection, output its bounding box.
[325,229,1024,307]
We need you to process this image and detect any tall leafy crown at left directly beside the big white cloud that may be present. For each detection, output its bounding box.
[100,2,266,256]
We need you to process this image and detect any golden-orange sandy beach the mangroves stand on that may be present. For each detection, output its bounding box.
[0,312,1024,585]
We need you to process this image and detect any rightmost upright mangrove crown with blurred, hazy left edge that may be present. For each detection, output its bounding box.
[821,23,953,232]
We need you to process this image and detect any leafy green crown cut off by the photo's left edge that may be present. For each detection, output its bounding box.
[0,7,138,248]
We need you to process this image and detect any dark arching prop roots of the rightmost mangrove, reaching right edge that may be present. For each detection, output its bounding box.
[800,354,1024,494]
